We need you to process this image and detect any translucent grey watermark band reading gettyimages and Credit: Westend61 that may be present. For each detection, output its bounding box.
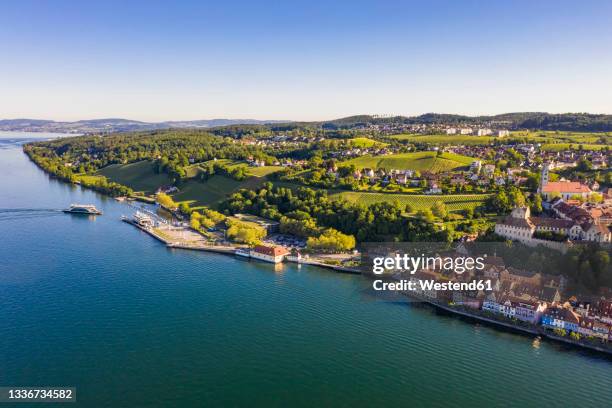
[360,242,610,305]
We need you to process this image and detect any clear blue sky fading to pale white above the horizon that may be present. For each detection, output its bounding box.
[0,0,612,121]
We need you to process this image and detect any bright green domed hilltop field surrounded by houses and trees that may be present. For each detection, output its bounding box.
[342,152,474,173]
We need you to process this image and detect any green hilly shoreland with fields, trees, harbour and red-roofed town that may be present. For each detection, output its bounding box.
[24,114,612,354]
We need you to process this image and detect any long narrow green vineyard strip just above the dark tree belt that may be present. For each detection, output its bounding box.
[330,191,489,211]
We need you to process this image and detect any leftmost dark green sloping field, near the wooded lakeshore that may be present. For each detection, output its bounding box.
[99,161,172,194]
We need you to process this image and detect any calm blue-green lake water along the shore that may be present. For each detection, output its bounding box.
[0,135,612,407]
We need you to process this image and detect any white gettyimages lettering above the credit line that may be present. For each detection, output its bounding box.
[372,254,486,275]
